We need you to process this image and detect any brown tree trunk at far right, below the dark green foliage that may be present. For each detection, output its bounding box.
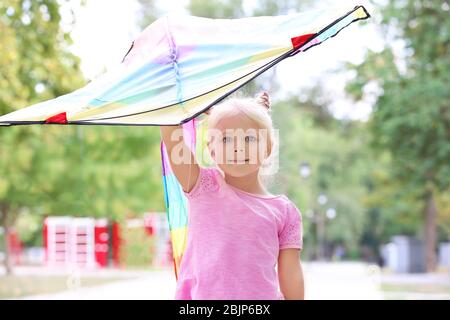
[425,191,437,272]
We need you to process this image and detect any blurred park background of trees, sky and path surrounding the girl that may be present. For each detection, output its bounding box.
[0,0,450,299]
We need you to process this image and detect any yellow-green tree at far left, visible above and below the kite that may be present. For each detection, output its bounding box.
[0,0,83,273]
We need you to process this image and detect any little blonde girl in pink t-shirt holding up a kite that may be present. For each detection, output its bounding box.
[161,92,304,300]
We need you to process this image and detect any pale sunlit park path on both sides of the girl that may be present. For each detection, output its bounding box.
[15,263,383,300]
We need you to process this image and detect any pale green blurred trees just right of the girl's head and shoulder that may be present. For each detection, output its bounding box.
[271,92,372,257]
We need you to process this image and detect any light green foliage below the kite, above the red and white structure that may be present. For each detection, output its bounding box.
[36,126,164,219]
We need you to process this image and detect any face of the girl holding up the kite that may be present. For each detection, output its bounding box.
[208,114,268,177]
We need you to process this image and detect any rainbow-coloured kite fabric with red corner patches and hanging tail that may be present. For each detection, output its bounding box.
[0,6,370,278]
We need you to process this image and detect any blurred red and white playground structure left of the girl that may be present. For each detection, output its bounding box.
[43,213,172,268]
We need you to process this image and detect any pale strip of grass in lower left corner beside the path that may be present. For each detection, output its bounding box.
[0,275,129,299]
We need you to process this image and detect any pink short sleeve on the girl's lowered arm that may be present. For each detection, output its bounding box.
[278,203,303,250]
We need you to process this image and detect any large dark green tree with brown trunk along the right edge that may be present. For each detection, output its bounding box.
[347,0,450,271]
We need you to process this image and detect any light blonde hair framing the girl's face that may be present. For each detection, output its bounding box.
[207,97,277,174]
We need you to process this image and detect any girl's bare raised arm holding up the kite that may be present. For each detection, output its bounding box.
[160,125,200,192]
